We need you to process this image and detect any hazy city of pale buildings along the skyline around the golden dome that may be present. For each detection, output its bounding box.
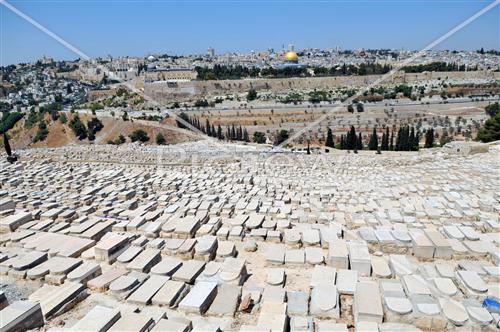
[0,45,500,114]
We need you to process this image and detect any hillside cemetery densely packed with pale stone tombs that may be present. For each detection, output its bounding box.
[0,142,500,332]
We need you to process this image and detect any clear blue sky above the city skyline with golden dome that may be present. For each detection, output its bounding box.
[0,0,500,66]
